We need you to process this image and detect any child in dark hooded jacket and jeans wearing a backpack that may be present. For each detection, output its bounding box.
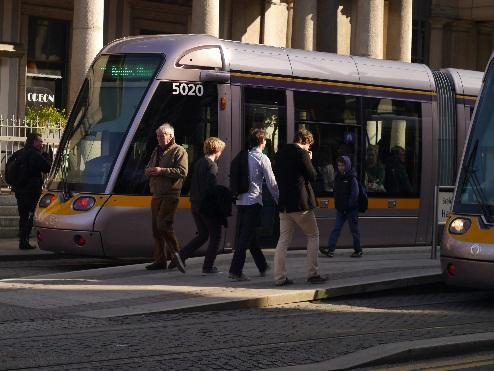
[319,156,362,258]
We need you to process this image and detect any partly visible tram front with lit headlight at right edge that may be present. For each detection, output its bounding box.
[441,56,494,289]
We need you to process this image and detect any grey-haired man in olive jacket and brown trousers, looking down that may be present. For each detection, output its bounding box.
[145,123,188,273]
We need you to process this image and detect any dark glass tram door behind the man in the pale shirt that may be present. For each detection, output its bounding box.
[241,87,286,247]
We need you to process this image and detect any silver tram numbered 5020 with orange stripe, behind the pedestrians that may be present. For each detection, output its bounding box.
[35,35,482,257]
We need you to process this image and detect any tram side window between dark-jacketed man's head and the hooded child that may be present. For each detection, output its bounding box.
[294,92,360,196]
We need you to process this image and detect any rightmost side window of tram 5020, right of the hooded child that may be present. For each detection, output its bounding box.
[364,98,422,197]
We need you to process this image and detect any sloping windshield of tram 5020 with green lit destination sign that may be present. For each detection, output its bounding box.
[48,54,163,192]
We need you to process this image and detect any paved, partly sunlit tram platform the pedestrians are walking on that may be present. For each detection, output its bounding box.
[0,247,440,318]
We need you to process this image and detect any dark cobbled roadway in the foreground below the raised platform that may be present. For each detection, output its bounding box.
[0,285,494,370]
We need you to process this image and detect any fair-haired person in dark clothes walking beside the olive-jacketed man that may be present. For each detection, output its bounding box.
[179,137,225,274]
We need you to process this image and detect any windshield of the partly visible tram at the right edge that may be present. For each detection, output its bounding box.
[454,60,494,221]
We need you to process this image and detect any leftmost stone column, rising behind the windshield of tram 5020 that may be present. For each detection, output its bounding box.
[69,0,105,109]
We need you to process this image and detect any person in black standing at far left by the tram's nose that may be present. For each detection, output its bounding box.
[13,132,52,250]
